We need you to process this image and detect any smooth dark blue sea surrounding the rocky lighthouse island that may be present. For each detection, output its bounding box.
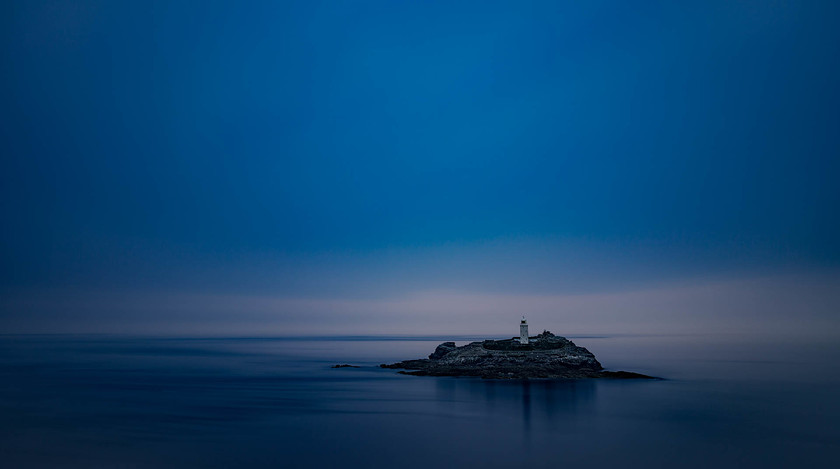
[0,336,840,468]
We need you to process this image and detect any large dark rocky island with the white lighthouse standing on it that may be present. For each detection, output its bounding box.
[380,331,652,379]
